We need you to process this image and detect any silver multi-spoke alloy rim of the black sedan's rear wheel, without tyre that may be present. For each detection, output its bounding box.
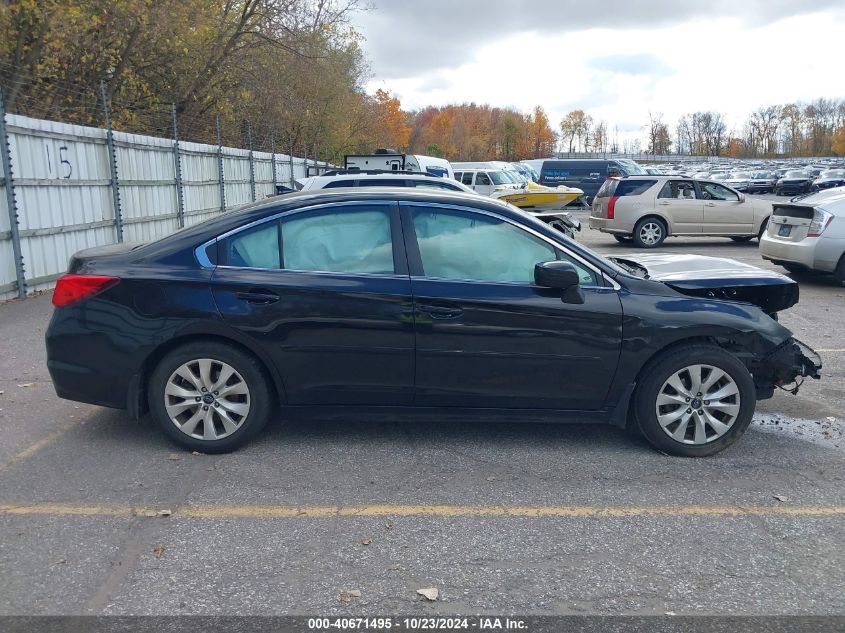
[164,358,250,441]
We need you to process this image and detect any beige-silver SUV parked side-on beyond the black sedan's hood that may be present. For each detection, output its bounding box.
[590,176,772,248]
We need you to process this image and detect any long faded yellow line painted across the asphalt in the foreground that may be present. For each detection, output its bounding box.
[0,503,845,519]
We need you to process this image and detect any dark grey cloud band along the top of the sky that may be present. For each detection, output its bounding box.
[356,0,842,80]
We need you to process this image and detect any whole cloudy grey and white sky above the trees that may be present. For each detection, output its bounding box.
[356,0,845,143]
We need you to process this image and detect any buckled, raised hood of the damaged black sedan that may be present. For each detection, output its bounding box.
[615,253,798,314]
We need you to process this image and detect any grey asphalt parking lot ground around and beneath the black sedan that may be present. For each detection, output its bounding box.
[0,195,845,615]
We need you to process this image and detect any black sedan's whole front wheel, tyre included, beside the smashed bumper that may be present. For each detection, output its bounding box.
[634,345,756,457]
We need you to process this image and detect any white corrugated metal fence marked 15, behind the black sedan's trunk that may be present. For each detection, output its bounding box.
[0,110,329,301]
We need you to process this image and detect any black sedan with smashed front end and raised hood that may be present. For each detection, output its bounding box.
[47,188,821,456]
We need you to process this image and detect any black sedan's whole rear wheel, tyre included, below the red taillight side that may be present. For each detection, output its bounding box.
[148,341,273,453]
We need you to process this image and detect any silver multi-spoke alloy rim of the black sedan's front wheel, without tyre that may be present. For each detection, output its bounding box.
[656,365,741,444]
